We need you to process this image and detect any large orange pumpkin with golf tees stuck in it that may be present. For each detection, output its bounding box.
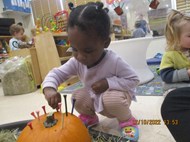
[17,112,91,142]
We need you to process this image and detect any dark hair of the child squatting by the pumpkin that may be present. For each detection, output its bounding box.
[68,2,110,39]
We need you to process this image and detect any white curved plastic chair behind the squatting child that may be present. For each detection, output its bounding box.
[108,37,154,85]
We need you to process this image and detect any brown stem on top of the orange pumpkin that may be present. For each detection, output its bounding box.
[44,112,58,128]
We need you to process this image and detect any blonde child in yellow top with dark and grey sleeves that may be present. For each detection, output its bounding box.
[160,10,190,86]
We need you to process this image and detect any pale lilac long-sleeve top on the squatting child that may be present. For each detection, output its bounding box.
[42,50,139,112]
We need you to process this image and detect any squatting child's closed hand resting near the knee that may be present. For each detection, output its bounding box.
[91,79,109,94]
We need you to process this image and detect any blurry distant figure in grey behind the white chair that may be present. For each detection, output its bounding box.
[133,21,146,38]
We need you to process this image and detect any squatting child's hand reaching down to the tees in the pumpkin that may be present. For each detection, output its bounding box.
[43,87,61,109]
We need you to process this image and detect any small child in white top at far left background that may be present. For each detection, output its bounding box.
[9,24,26,50]
